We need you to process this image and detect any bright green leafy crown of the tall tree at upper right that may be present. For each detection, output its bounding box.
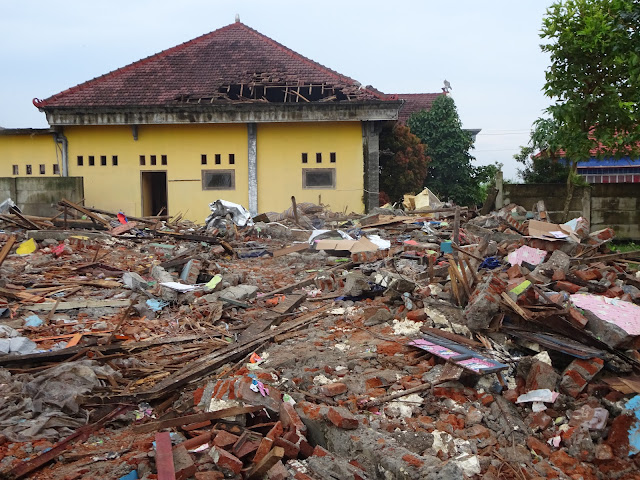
[540,0,640,163]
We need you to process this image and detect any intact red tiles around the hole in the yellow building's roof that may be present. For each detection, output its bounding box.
[34,22,387,108]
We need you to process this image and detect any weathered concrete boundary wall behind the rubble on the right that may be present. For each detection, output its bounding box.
[496,183,640,240]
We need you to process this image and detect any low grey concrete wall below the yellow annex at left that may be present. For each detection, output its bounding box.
[0,177,84,217]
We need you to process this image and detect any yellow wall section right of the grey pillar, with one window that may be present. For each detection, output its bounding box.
[257,122,364,213]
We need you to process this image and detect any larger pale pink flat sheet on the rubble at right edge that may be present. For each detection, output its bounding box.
[571,293,640,336]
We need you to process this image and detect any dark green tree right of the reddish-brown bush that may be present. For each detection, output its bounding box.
[407,95,499,205]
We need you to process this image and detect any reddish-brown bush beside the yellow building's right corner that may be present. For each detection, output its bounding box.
[380,124,429,204]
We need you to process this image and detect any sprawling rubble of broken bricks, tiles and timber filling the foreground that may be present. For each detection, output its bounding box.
[0,193,640,480]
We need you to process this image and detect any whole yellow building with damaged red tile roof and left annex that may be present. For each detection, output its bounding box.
[0,22,412,219]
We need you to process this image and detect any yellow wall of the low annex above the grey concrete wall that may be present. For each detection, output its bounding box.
[0,134,62,177]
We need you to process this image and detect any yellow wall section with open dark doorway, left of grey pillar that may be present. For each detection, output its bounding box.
[65,124,248,223]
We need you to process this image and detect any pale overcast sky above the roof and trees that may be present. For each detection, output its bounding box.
[0,0,552,179]
